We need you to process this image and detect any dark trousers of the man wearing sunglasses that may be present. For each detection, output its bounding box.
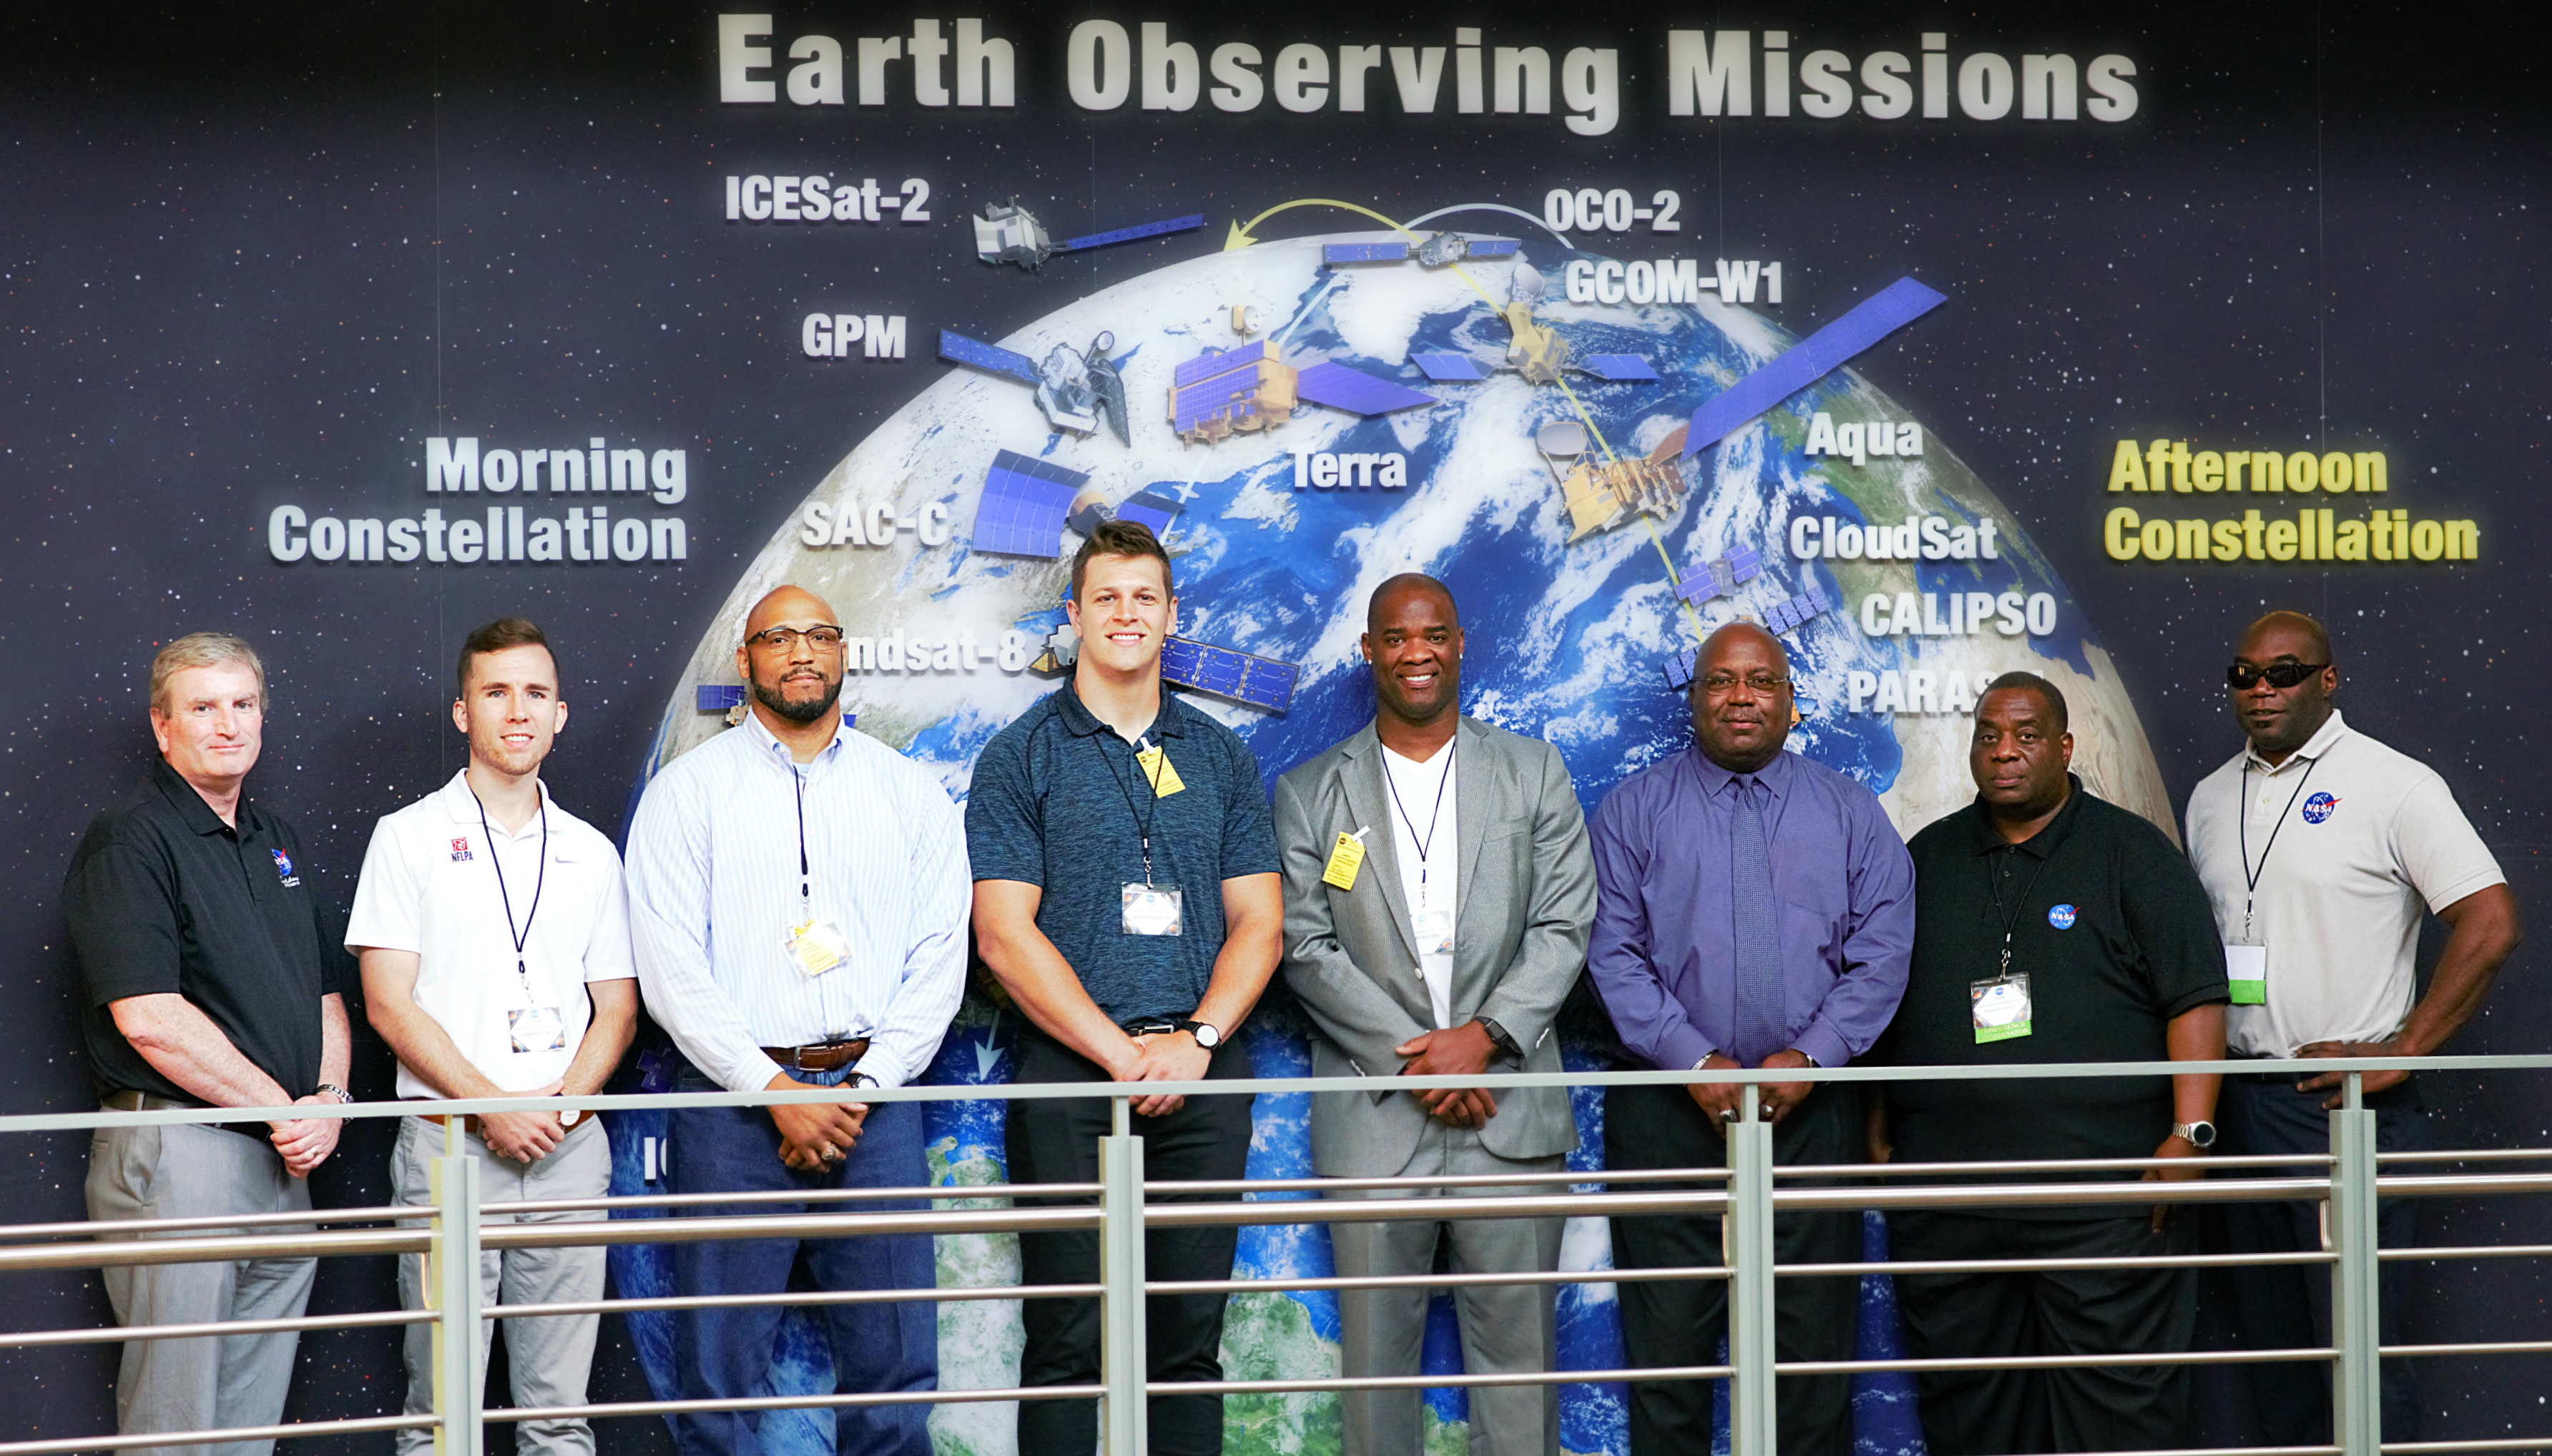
[2215,1076,2430,1446]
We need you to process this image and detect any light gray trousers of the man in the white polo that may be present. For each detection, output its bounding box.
[391,1117,612,1456]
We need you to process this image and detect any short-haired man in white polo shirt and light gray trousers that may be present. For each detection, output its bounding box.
[345,617,638,1456]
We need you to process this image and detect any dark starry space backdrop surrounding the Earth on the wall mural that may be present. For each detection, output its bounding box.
[0,3,2552,1451]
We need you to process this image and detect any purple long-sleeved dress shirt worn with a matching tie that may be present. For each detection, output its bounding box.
[1587,747,1914,1071]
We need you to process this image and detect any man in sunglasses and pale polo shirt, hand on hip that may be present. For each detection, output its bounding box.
[2189,612,2519,1446]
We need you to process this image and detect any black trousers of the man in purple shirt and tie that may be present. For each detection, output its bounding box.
[1603,1081,1863,1456]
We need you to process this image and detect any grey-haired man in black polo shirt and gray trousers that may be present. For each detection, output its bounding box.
[62,632,350,1456]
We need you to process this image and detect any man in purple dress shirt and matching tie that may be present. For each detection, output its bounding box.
[1587,622,1914,1456]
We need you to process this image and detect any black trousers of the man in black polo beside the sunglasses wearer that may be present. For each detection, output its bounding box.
[1888,1209,2197,1456]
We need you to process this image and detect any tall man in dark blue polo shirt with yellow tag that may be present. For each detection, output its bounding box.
[965,523,1284,1456]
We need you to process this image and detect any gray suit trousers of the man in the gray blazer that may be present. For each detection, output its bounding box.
[1330,1119,1567,1456]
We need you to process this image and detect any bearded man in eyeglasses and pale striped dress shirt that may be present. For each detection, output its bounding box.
[628,586,967,1456]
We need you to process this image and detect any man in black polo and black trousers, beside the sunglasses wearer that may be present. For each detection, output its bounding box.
[1870,673,2228,1456]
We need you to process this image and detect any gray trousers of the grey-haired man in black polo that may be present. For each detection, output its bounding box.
[87,1124,316,1456]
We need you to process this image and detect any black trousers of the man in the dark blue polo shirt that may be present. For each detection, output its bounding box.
[1008,1033,1250,1456]
